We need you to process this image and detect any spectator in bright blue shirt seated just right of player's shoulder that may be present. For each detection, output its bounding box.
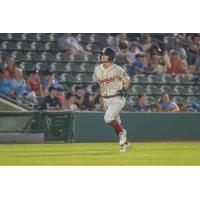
[127,54,144,76]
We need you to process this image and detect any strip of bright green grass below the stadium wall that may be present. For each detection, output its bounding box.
[0,142,200,166]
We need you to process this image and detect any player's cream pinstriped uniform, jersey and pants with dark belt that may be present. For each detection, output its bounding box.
[93,64,130,124]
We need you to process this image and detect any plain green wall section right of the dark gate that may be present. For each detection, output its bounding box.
[73,112,200,142]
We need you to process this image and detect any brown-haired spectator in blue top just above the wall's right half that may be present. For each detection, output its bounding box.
[159,93,179,112]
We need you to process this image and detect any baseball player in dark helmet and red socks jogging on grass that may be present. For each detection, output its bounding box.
[93,47,131,152]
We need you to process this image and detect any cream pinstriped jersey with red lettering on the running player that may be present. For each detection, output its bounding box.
[93,64,130,96]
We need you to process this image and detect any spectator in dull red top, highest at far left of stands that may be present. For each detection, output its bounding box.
[5,58,16,80]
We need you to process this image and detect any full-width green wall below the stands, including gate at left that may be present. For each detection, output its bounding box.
[0,111,200,142]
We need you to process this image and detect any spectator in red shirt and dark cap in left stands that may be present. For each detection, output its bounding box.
[27,69,42,96]
